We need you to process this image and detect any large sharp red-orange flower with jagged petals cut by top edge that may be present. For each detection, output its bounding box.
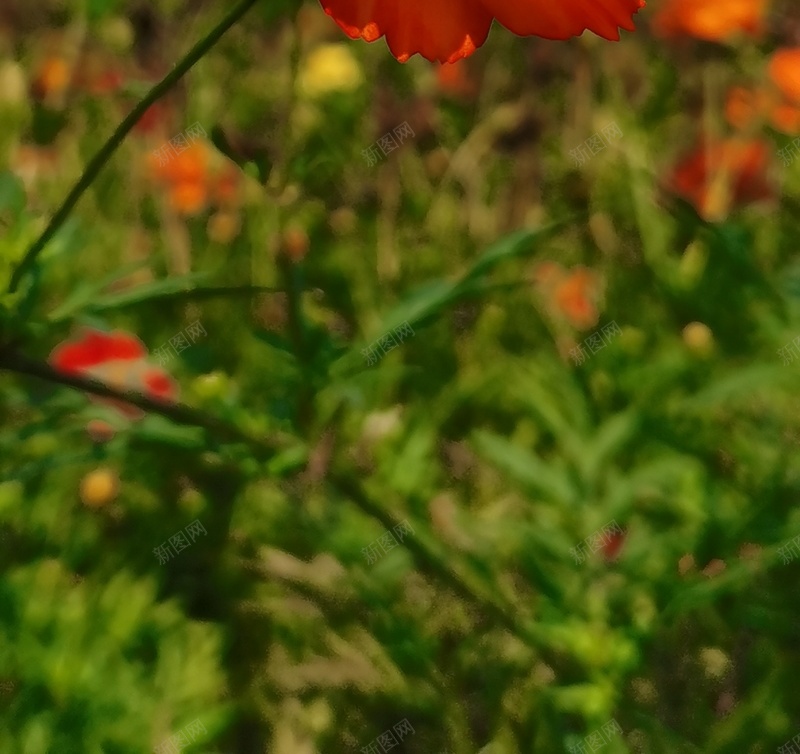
[320,0,644,63]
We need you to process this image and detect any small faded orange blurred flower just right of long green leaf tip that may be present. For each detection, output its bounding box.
[533,262,600,330]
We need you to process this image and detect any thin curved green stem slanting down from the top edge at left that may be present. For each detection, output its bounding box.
[8,0,258,293]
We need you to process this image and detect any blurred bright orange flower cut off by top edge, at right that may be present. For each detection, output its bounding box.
[653,0,768,42]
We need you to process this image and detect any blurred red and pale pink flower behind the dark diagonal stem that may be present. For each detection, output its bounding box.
[48,329,178,419]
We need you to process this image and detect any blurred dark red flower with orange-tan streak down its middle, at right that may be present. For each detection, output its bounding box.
[669,139,774,222]
